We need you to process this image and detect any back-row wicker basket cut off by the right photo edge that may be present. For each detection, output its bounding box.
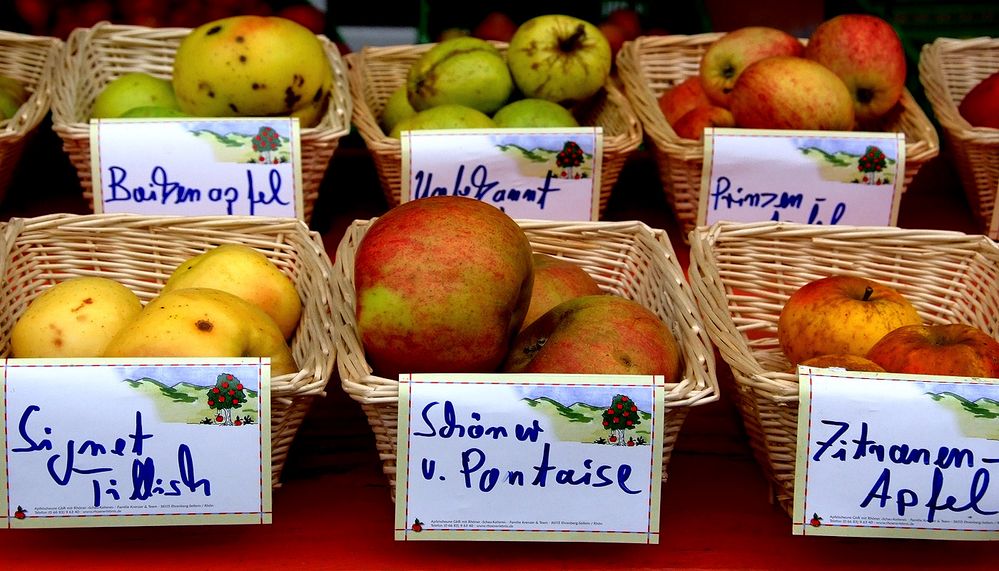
[919,38,999,236]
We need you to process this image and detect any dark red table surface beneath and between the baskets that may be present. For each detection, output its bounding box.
[0,132,999,570]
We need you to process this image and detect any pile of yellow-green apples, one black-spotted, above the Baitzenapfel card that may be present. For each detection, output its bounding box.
[91,15,334,127]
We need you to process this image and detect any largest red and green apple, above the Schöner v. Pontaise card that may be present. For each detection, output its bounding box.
[354,196,533,378]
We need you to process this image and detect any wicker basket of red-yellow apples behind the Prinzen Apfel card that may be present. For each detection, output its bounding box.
[617,33,940,238]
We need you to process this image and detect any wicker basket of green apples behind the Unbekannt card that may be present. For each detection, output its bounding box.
[344,43,642,219]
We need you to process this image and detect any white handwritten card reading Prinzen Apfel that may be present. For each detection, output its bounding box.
[698,129,905,226]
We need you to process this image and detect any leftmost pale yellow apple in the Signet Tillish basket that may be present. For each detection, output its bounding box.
[10,276,142,358]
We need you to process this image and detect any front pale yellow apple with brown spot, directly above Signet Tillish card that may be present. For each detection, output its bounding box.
[104,288,298,376]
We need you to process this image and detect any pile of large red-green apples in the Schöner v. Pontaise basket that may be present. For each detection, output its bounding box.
[354,196,682,382]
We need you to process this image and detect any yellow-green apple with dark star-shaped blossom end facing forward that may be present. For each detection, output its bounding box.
[507,14,613,103]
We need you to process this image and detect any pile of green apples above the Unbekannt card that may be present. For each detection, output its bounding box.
[379,14,612,138]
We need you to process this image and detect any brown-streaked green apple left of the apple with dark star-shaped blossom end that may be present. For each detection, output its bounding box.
[406,36,513,114]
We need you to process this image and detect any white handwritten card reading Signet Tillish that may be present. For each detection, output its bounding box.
[0,359,271,528]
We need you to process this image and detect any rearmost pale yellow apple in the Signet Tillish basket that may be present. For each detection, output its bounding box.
[162,244,302,339]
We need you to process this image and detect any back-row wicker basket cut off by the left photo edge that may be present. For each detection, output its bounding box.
[0,30,63,201]
